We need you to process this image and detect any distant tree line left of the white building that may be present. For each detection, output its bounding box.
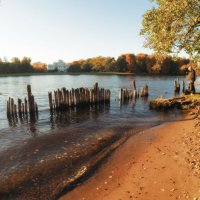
[0,57,47,74]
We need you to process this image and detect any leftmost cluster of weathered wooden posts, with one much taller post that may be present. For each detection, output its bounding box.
[7,85,38,118]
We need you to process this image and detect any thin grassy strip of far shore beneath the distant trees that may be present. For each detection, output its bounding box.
[0,72,184,77]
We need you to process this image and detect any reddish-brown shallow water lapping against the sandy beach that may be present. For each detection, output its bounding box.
[0,123,157,200]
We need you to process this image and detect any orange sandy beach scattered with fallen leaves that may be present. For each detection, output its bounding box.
[60,111,200,200]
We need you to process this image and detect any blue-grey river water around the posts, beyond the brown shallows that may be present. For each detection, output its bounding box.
[0,75,190,150]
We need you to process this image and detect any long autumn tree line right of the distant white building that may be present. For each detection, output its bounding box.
[68,54,190,75]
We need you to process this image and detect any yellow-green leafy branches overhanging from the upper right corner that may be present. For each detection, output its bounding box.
[141,0,200,61]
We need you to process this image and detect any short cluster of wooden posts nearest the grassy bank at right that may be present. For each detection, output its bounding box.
[119,80,149,102]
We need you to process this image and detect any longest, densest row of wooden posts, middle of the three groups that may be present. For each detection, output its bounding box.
[48,83,111,111]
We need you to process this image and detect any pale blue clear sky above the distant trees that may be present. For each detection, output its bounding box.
[0,0,153,64]
